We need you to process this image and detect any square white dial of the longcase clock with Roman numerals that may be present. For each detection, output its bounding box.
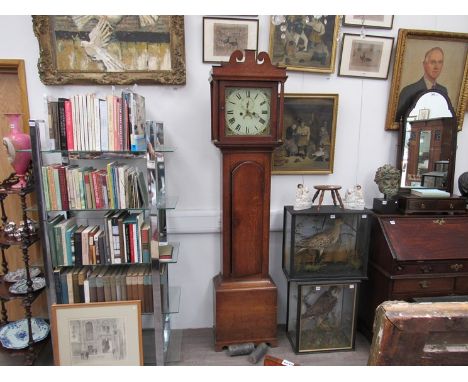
[225,88,271,135]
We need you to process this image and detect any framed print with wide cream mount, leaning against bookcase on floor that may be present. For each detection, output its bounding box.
[51,300,143,366]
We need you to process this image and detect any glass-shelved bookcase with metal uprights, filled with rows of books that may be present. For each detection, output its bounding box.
[30,93,180,365]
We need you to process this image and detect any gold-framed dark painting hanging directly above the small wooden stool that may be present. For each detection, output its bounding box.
[272,94,338,174]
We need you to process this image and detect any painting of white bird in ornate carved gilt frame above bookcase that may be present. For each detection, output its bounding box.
[32,15,185,85]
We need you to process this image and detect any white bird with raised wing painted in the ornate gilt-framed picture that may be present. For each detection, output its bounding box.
[81,17,125,72]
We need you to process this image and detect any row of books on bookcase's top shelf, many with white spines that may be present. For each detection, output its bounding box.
[41,91,146,151]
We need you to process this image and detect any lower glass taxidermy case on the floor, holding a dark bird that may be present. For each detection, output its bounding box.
[286,281,359,353]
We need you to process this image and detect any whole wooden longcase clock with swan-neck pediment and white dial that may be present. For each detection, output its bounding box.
[210,50,287,351]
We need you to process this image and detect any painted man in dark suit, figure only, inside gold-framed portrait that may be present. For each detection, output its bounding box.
[395,46,448,121]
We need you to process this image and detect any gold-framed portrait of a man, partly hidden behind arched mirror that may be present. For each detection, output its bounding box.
[385,29,468,130]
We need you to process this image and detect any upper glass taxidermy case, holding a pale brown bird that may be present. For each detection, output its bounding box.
[283,206,371,280]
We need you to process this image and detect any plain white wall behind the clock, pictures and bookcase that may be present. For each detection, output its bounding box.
[0,12,468,328]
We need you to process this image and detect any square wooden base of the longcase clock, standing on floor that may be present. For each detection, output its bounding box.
[213,274,278,351]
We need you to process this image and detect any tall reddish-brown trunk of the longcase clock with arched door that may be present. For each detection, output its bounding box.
[223,152,271,278]
